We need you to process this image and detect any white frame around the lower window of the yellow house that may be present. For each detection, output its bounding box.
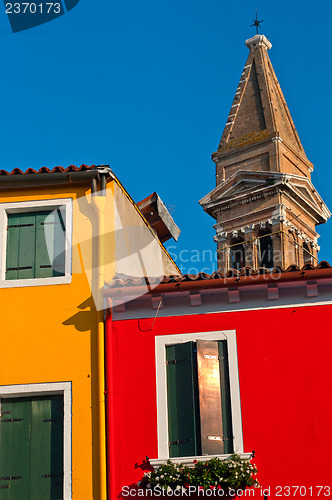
[0,382,72,500]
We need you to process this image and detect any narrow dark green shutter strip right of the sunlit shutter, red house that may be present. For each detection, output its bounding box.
[218,340,234,453]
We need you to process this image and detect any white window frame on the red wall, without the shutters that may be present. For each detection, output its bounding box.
[150,330,246,466]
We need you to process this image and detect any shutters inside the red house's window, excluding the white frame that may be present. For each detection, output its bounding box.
[166,340,233,457]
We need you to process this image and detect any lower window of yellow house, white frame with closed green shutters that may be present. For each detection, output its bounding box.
[0,382,71,500]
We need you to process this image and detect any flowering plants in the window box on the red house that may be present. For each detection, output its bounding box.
[141,453,259,494]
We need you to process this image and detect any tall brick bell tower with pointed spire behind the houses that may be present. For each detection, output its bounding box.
[200,35,331,272]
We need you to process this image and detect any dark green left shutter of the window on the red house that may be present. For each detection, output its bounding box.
[166,342,201,457]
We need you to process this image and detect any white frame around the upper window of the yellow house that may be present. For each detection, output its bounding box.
[0,198,73,288]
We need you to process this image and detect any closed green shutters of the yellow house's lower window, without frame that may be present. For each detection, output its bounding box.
[0,395,63,500]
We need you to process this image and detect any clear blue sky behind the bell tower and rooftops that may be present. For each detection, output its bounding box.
[0,0,332,272]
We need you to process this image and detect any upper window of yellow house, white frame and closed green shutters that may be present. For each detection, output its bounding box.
[0,199,72,287]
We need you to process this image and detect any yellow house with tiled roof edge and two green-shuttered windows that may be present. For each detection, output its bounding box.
[0,165,179,500]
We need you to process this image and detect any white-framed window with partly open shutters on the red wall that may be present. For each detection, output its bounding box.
[152,330,243,463]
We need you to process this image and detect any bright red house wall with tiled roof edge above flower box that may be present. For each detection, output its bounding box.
[106,262,332,500]
